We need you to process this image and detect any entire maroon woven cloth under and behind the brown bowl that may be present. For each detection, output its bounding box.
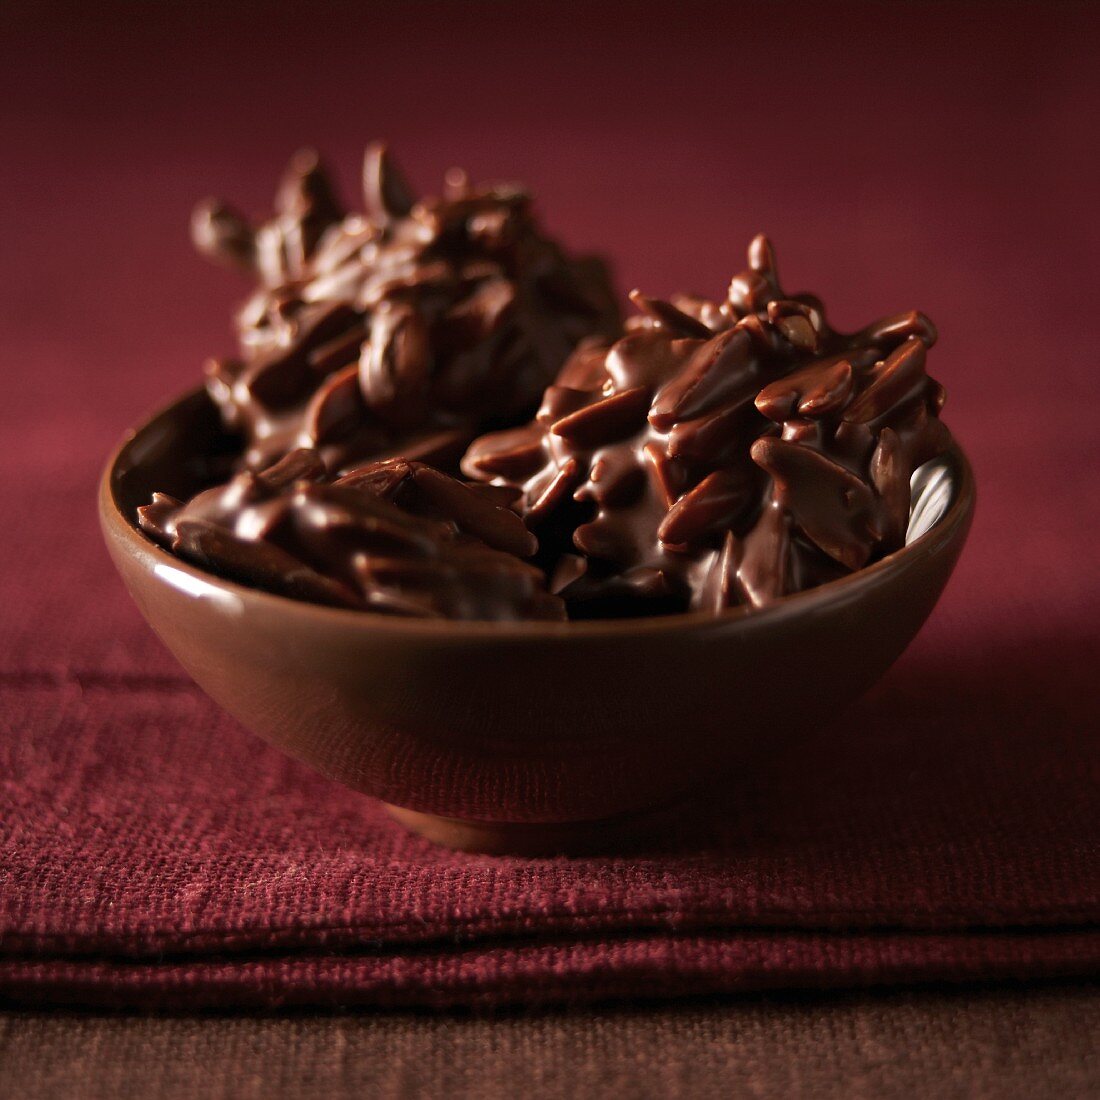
[0,4,1100,1007]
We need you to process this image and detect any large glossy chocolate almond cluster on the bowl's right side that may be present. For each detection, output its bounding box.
[462,237,949,616]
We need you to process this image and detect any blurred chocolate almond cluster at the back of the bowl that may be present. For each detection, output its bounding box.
[191,145,618,470]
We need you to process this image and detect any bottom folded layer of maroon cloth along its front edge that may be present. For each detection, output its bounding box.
[0,932,1097,1011]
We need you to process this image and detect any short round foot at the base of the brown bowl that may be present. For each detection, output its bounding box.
[383,800,692,856]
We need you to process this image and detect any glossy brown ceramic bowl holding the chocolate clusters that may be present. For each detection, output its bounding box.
[99,393,975,851]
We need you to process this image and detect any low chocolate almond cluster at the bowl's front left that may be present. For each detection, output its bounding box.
[138,449,565,620]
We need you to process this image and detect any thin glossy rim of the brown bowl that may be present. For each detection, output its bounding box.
[98,386,977,639]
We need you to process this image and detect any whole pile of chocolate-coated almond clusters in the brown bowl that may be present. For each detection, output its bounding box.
[139,145,950,620]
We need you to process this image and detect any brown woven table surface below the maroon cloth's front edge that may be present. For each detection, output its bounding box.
[0,986,1100,1100]
